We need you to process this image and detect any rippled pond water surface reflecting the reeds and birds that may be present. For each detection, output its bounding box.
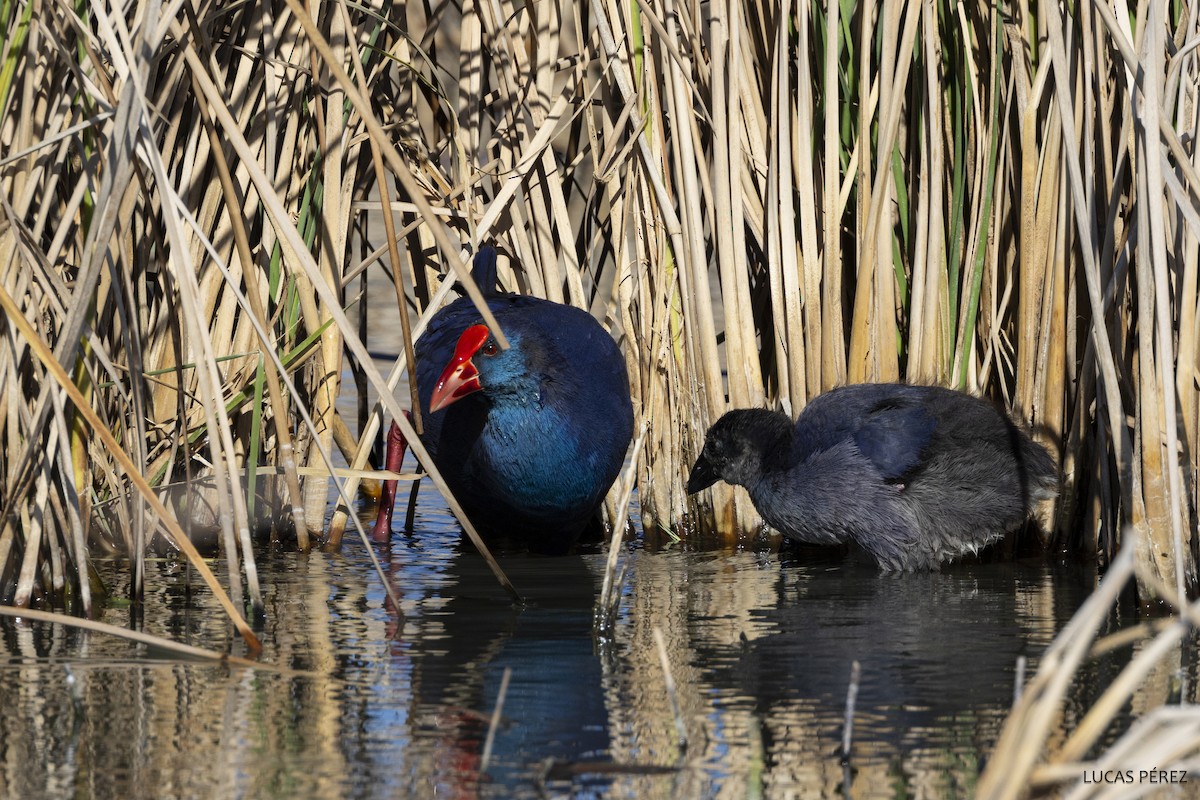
[0,489,1180,798]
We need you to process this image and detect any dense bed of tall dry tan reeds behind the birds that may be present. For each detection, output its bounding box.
[0,0,1200,786]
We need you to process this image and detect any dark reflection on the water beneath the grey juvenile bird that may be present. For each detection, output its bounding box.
[726,566,1079,714]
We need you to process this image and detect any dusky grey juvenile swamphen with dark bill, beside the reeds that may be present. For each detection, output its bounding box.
[688,384,1056,570]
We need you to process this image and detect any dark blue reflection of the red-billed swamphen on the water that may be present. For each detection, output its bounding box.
[364,539,610,796]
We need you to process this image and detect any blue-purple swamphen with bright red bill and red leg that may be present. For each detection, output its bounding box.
[373,246,634,552]
